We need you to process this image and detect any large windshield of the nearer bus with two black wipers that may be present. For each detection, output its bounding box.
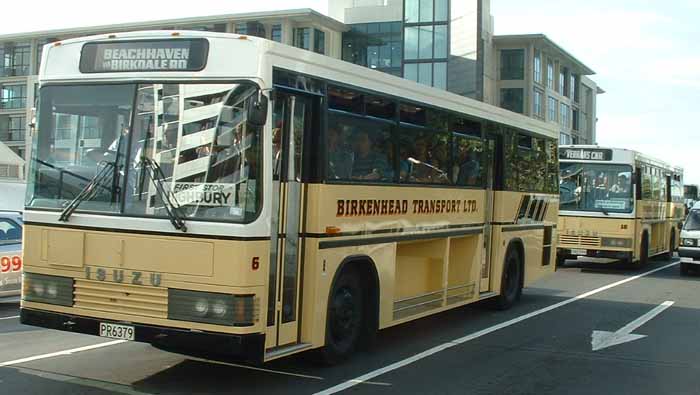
[27,83,262,222]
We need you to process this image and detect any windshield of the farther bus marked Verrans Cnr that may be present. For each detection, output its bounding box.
[559,162,634,213]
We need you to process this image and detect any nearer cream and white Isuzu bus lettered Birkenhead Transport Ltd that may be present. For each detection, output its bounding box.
[21,31,558,363]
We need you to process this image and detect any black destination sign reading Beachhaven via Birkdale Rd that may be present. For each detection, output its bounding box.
[80,38,209,73]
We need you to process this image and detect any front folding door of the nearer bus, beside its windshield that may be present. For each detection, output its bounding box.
[265,90,315,349]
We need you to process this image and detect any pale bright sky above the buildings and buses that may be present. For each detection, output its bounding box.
[0,0,700,184]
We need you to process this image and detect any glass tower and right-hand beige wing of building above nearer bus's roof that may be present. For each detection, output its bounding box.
[328,0,603,144]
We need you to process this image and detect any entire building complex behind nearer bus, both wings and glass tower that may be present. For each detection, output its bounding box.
[0,0,603,164]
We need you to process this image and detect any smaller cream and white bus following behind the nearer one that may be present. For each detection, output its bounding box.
[557,145,684,265]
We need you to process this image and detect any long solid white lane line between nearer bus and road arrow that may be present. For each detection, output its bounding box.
[315,261,678,395]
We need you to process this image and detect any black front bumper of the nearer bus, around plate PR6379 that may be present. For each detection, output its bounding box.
[20,308,265,364]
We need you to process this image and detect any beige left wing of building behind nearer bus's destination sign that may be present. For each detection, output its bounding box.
[0,9,349,164]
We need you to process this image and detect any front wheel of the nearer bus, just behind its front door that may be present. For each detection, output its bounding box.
[321,270,365,365]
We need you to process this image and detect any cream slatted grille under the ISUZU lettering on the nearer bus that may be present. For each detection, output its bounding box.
[74,279,168,318]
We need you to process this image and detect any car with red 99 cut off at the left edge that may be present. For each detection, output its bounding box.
[0,211,23,300]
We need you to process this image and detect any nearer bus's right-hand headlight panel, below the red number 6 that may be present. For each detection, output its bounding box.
[168,289,258,326]
